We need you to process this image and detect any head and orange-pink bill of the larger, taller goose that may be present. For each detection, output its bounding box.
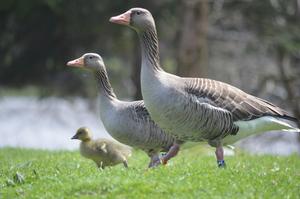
[109,8,155,32]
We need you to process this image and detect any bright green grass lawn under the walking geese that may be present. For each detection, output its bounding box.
[0,147,300,199]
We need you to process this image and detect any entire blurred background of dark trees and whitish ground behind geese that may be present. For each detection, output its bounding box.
[0,0,300,155]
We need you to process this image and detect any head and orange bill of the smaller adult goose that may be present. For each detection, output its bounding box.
[67,53,105,71]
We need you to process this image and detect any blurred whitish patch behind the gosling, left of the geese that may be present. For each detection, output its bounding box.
[0,97,111,149]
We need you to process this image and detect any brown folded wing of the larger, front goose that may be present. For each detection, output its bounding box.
[184,78,297,121]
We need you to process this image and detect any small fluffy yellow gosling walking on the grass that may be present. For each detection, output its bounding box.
[71,127,131,169]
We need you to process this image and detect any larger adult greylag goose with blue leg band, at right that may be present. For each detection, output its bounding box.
[110,8,299,167]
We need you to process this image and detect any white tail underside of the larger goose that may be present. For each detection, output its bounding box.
[222,116,300,145]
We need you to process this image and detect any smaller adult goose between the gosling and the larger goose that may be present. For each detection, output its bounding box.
[67,53,181,167]
